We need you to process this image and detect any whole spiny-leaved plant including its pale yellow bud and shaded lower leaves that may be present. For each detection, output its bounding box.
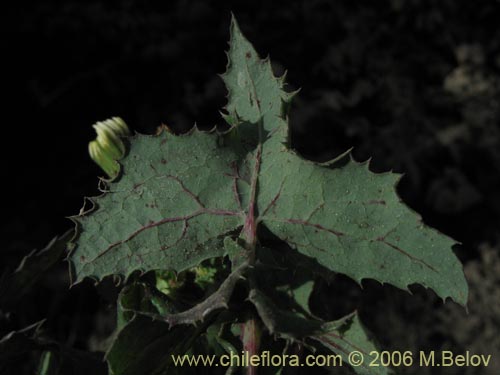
[69,19,468,375]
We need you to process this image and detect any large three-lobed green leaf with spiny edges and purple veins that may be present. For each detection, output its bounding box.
[71,16,467,304]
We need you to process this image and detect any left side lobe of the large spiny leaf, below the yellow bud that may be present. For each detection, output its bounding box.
[71,129,243,281]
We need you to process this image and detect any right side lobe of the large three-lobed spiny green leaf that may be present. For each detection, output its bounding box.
[259,152,467,304]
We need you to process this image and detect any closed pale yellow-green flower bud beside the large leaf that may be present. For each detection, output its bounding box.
[89,117,130,178]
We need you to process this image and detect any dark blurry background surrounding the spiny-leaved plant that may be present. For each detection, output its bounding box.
[0,0,500,374]
